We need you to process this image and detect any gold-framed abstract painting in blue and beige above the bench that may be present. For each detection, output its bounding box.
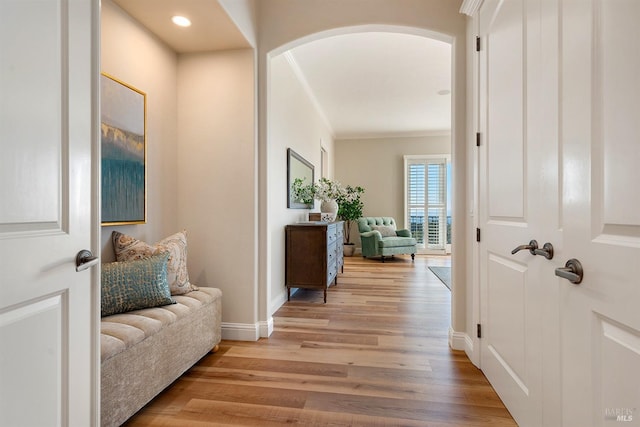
[100,73,147,225]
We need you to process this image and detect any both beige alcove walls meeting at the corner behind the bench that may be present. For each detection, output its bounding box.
[101,0,258,339]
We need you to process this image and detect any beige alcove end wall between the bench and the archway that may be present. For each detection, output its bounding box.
[172,49,257,332]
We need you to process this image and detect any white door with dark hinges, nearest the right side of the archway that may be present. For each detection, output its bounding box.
[478,0,561,426]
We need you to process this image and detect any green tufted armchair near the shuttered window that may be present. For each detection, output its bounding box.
[358,217,416,262]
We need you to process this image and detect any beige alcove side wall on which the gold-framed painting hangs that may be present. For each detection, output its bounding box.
[101,0,180,262]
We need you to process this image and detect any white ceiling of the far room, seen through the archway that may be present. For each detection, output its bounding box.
[290,32,451,138]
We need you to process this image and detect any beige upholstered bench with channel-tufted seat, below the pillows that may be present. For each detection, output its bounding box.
[100,287,222,426]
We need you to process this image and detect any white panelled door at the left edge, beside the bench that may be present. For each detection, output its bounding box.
[0,0,99,427]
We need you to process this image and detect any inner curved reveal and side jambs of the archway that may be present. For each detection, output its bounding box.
[260,25,467,352]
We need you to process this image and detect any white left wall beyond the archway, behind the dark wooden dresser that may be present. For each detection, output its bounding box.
[268,55,333,316]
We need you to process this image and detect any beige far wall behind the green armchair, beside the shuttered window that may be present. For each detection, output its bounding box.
[335,135,451,247]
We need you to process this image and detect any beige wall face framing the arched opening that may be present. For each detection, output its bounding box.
[258,0,468,342]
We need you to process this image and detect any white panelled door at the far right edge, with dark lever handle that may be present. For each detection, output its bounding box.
[556,0,640,426]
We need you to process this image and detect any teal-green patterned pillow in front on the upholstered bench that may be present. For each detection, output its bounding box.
[101,253,175,317]
